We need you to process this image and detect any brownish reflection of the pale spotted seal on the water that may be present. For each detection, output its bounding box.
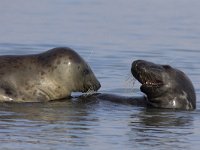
[0,99,99,123]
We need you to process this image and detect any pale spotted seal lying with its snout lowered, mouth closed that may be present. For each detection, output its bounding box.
[0,48,100,102]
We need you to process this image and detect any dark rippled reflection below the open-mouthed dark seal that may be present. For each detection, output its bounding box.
[129,109,193,149]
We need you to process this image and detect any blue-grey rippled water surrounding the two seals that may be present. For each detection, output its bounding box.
[0,0,200,150]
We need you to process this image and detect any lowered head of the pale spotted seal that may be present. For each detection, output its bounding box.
[38,48,101,92]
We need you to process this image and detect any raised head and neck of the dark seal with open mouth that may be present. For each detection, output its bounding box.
[131,60,196,110]
